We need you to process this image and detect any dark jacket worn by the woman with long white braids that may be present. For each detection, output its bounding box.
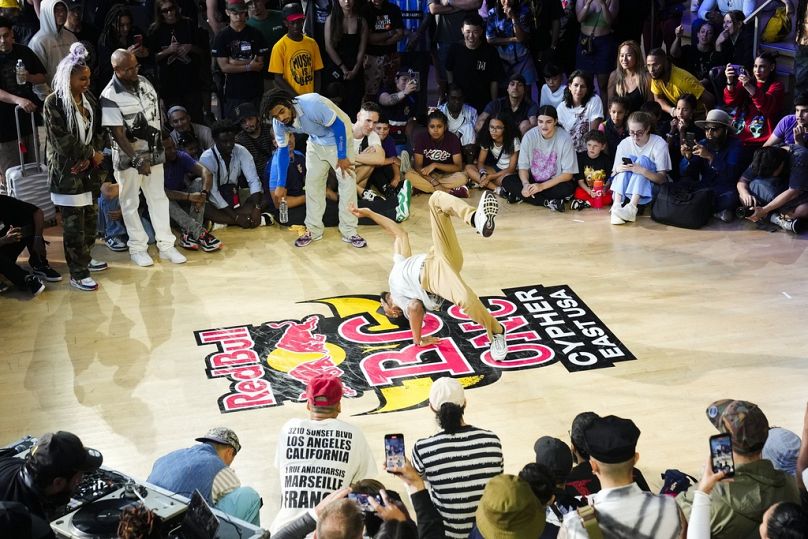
[43,92,106,196]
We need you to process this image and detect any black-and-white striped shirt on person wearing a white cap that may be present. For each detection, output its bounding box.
[412,425,503,539]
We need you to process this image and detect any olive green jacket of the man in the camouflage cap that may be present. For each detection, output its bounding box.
[676,459,800,539]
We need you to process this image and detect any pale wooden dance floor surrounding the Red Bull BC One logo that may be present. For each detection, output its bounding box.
[0,193,808,526]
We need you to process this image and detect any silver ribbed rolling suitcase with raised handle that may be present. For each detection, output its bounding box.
[6,106,56,222]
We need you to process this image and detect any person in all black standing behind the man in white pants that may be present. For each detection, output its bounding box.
[146,0,209,123]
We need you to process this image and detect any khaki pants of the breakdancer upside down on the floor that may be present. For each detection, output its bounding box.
[421,192,502,338]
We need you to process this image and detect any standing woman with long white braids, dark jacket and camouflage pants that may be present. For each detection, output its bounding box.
[43,42,107,292]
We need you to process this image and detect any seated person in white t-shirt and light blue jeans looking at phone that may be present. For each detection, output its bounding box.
[610,111,671,225]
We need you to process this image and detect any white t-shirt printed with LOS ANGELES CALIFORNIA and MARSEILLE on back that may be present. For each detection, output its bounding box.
[270,419,376,534]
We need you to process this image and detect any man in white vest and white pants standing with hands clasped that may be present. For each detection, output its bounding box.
[101,49,186,267]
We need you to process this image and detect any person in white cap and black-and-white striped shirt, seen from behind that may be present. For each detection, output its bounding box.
[412,377,502,539]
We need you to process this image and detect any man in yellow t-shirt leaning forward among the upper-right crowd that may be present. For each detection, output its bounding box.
[645,49,715,118]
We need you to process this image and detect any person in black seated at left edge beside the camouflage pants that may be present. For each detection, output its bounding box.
[0,195,55,296]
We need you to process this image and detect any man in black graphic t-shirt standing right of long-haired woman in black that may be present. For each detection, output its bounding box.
[362,0,404,99]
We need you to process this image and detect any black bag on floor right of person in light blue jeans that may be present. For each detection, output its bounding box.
[651,183,715,229]
